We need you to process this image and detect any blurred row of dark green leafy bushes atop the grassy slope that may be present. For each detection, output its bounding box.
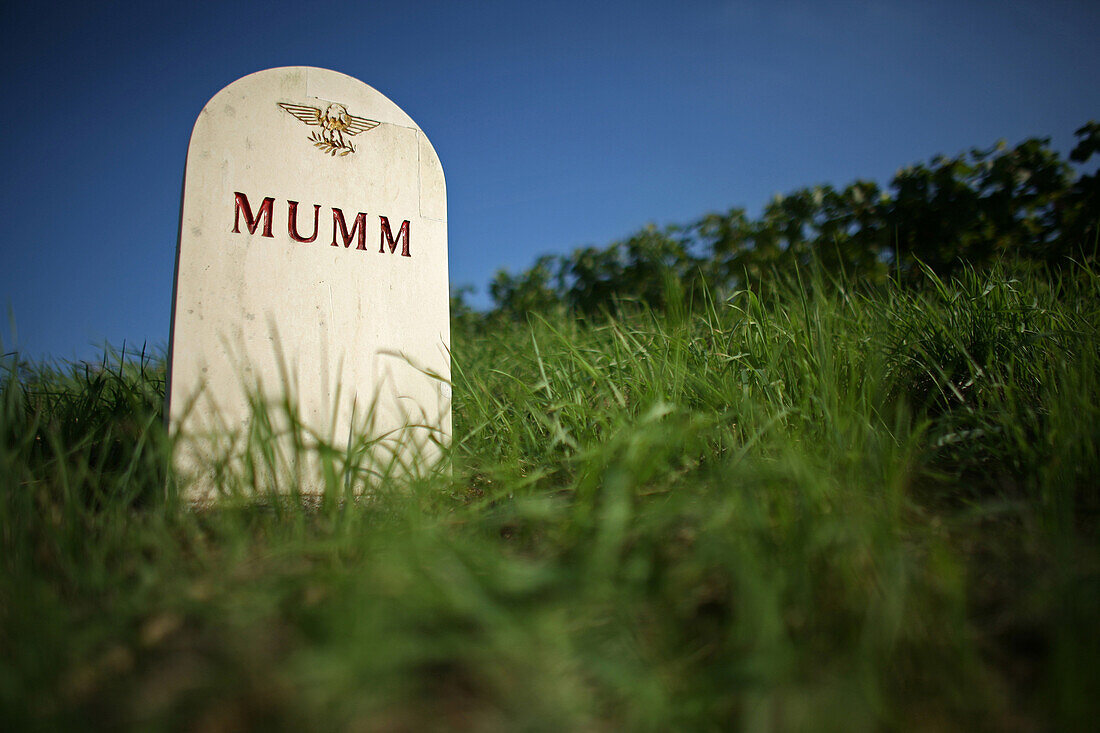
[481,122,1100,319]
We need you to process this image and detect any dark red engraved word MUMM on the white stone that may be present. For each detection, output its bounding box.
[233,193,413,258]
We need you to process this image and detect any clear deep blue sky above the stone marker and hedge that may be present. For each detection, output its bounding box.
[0,0,1100,359]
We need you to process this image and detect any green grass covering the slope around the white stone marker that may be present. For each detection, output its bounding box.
[0,270,1100,731]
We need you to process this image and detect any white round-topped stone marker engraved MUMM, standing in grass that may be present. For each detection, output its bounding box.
[168,67,451,500]
